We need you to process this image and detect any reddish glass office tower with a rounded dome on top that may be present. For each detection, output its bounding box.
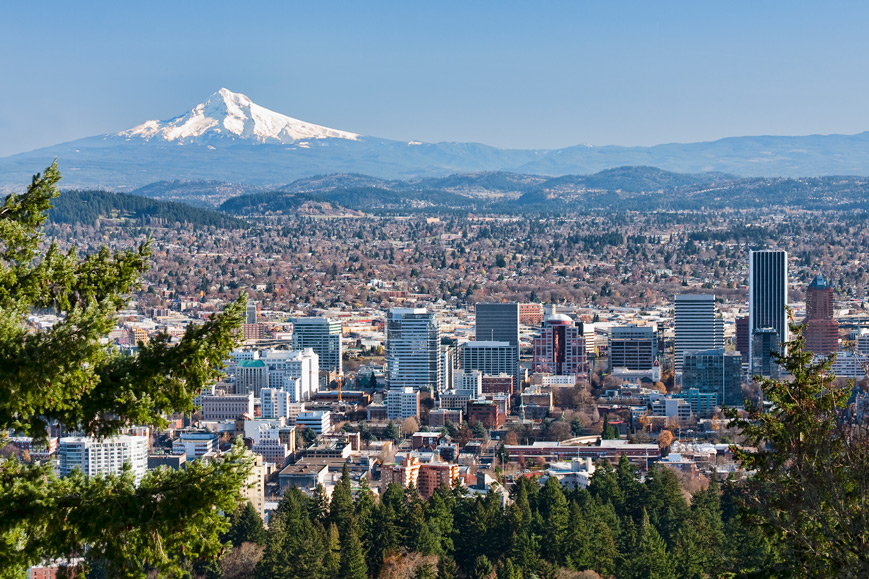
[532,314,588,378]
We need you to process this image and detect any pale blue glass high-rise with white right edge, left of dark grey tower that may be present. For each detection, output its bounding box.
[386,308,443,390]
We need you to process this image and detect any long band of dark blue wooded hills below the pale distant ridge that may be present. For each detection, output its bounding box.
[221,166,869,215]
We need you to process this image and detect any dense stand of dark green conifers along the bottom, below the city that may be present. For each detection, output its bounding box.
[210,464,778,579]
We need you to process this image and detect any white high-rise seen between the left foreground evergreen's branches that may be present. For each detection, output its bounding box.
[57,435,148,483]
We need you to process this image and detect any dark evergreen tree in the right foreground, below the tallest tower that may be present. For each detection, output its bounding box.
[730,325,869,577]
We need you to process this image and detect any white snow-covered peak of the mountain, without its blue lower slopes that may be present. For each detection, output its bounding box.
[117,88,359,143]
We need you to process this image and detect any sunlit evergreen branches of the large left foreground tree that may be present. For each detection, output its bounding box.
[0,163,250,577]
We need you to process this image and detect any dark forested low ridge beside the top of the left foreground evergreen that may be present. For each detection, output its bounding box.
[48,191,249,229]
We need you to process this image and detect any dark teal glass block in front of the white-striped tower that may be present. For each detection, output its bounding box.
[682,348,743,406]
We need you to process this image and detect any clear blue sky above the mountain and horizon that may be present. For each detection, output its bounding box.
[0,0,869,156]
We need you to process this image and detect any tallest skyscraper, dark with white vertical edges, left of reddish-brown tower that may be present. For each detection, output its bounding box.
[748,249,788,374]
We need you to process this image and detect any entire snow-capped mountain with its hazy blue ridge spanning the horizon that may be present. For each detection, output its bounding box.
[0,89,869,193]
